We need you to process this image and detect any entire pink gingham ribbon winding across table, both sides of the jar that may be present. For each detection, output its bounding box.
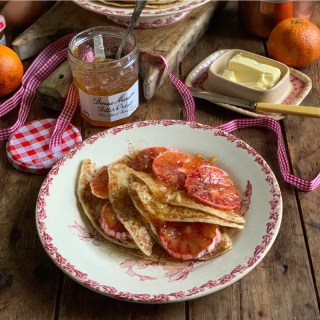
[0,34,320,191]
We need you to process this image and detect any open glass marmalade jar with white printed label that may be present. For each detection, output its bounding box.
[68,26,139,127]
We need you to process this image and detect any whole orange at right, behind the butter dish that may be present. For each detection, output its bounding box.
[268,18,320,68]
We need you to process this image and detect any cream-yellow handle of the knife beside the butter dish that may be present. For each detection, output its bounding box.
[256,102,320,118]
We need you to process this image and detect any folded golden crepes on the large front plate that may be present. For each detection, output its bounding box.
[77,151,245,261]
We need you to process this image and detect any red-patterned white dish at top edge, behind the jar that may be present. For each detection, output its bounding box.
[73,0,212,29]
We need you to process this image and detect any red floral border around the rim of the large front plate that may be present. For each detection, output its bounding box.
[36,120,281,303]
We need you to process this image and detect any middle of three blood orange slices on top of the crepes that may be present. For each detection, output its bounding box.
[152,151,207,188]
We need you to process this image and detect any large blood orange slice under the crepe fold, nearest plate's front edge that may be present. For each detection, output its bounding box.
[158,222,221,260]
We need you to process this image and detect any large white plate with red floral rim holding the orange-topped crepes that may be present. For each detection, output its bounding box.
[36,120,282,303]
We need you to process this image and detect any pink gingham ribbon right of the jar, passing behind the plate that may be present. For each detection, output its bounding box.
[144,52,320,191]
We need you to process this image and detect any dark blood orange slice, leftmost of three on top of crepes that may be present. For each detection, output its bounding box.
[127,147,169,173]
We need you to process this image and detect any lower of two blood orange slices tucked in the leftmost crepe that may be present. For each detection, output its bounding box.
[100,201,132,241]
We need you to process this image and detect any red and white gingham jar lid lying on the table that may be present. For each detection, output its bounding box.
[7,119,82,174]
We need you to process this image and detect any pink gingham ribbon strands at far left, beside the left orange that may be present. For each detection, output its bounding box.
[0,34,75,141]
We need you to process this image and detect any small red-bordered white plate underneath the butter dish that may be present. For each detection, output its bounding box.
[185,49,312,120]
